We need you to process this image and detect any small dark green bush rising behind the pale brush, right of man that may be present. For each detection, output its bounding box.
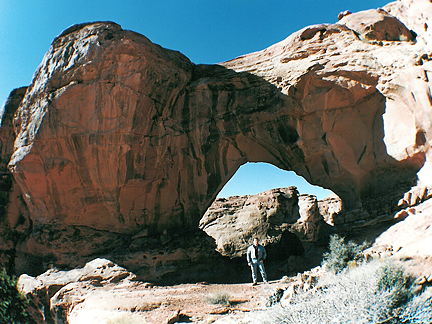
[322,234,369,273]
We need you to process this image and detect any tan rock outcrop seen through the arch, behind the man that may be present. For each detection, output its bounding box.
[200,187,328,260]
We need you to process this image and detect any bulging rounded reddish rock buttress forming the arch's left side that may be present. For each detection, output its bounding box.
[9,23,193,232]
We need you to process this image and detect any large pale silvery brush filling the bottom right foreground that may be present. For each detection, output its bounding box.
[245,261,424,324]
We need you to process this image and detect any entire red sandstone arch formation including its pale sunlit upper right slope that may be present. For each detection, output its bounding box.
[1,0,432,278]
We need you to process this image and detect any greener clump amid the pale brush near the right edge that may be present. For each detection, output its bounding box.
[377,263,414,308]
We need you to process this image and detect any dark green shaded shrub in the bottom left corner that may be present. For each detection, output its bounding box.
[0,269,31,324]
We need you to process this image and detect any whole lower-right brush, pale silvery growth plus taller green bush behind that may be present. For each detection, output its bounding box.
[249,236,432,324]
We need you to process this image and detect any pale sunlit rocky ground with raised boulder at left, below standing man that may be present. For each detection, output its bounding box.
[19,259,289,324]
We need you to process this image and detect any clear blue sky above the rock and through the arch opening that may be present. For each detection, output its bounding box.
[0,0,389,200]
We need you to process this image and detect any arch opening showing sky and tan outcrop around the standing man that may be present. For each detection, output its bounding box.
[199,162,337,282]
